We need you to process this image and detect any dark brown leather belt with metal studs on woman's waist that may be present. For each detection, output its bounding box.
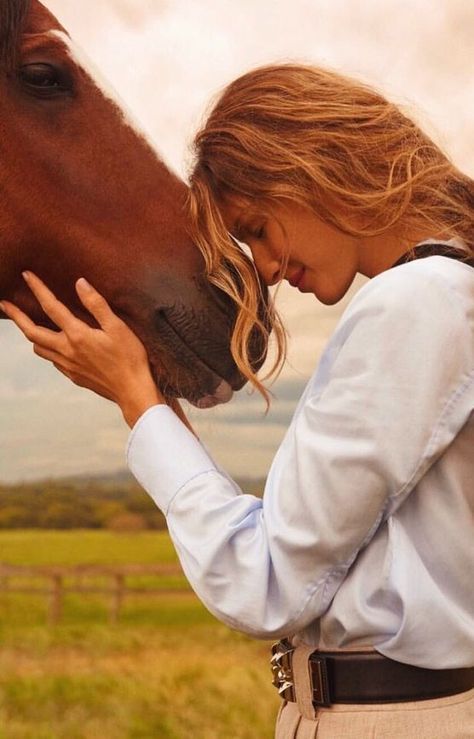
[271,639,474,707]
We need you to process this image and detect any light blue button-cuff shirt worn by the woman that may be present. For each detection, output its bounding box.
[128,256,474,668]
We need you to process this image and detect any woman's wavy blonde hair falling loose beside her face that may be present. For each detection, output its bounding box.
[188,64,474,400]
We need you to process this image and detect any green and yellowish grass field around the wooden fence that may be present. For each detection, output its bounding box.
[0,531,278,739]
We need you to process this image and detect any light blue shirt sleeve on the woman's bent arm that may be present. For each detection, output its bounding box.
[128,268,473,638]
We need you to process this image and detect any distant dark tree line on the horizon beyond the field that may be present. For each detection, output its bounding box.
[0,476,263,531]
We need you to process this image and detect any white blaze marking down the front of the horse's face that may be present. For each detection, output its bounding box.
[49,30,163,162]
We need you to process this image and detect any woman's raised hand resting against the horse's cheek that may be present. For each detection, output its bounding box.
[0,272,165,427]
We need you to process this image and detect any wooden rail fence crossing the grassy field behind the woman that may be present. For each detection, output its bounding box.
[0,563,192,626]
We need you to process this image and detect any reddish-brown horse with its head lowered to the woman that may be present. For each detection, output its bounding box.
[0,0,267,407]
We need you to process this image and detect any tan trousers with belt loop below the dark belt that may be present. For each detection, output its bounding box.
[275,647,474,739]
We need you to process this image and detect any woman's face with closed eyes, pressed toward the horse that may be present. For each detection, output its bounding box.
[220,199,358,305]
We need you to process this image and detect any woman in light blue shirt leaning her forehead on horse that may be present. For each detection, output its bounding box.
[3,65,474,739]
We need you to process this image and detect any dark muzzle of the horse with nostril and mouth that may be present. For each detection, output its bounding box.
[116,272,270,408]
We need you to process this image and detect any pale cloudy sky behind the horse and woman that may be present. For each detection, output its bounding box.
[0,0,474,484]
